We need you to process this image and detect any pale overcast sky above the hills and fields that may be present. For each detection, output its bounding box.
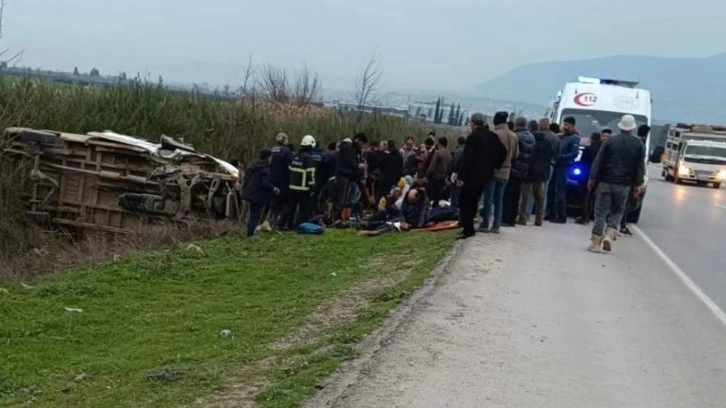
[2,0,726,90]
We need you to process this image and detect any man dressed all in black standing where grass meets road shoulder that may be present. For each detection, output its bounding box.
[456,113,508,239]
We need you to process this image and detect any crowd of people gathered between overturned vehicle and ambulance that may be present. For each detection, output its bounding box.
[241,112,650,251]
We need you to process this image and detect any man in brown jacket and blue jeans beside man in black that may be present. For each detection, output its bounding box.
[479,112,519,234]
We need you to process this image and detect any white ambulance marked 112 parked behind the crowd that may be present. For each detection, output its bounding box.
[546,77,652,223]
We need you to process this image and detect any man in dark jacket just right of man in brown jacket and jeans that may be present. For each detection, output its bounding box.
[502,116,534,227]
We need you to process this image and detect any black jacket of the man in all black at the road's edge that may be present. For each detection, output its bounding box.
[456,128,507,185]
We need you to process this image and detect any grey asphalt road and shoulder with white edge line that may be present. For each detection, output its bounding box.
[307,178,726,408]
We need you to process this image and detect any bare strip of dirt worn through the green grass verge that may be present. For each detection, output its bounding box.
[272,256,419,350]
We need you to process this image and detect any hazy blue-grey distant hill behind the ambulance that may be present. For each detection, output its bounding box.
[472,54,726,124]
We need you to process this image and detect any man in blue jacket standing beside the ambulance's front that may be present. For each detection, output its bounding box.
[550,116,580,224]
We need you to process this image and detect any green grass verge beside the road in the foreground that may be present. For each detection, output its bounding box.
[0,231,453,407]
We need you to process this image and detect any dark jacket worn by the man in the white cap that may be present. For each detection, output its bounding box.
[590,133,645,186]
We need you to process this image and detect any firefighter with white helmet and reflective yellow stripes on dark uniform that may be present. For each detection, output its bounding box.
[288,135,315,228]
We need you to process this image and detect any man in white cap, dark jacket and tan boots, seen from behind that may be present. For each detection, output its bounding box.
[588,115,645,252]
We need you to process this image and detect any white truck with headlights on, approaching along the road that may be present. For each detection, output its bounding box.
[663,123,726,188]
